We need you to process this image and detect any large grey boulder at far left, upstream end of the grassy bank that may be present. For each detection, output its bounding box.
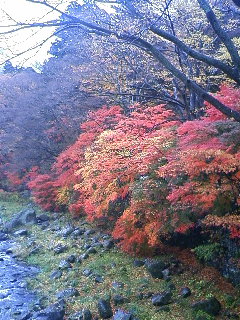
[4,208,37,232]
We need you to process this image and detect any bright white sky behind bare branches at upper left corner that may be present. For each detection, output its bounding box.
[0,0,79,67]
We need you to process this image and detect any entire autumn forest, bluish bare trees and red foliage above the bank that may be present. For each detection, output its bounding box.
[0,0,240,254]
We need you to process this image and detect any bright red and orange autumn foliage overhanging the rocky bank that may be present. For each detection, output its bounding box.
[29,86,240,254]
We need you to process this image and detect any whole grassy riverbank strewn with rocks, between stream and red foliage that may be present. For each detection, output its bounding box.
[0,195,240,320]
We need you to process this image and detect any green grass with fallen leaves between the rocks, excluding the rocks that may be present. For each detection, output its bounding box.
[0,191,240,320]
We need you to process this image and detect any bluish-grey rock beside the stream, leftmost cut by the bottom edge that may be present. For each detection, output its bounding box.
[33,302,65,320]
